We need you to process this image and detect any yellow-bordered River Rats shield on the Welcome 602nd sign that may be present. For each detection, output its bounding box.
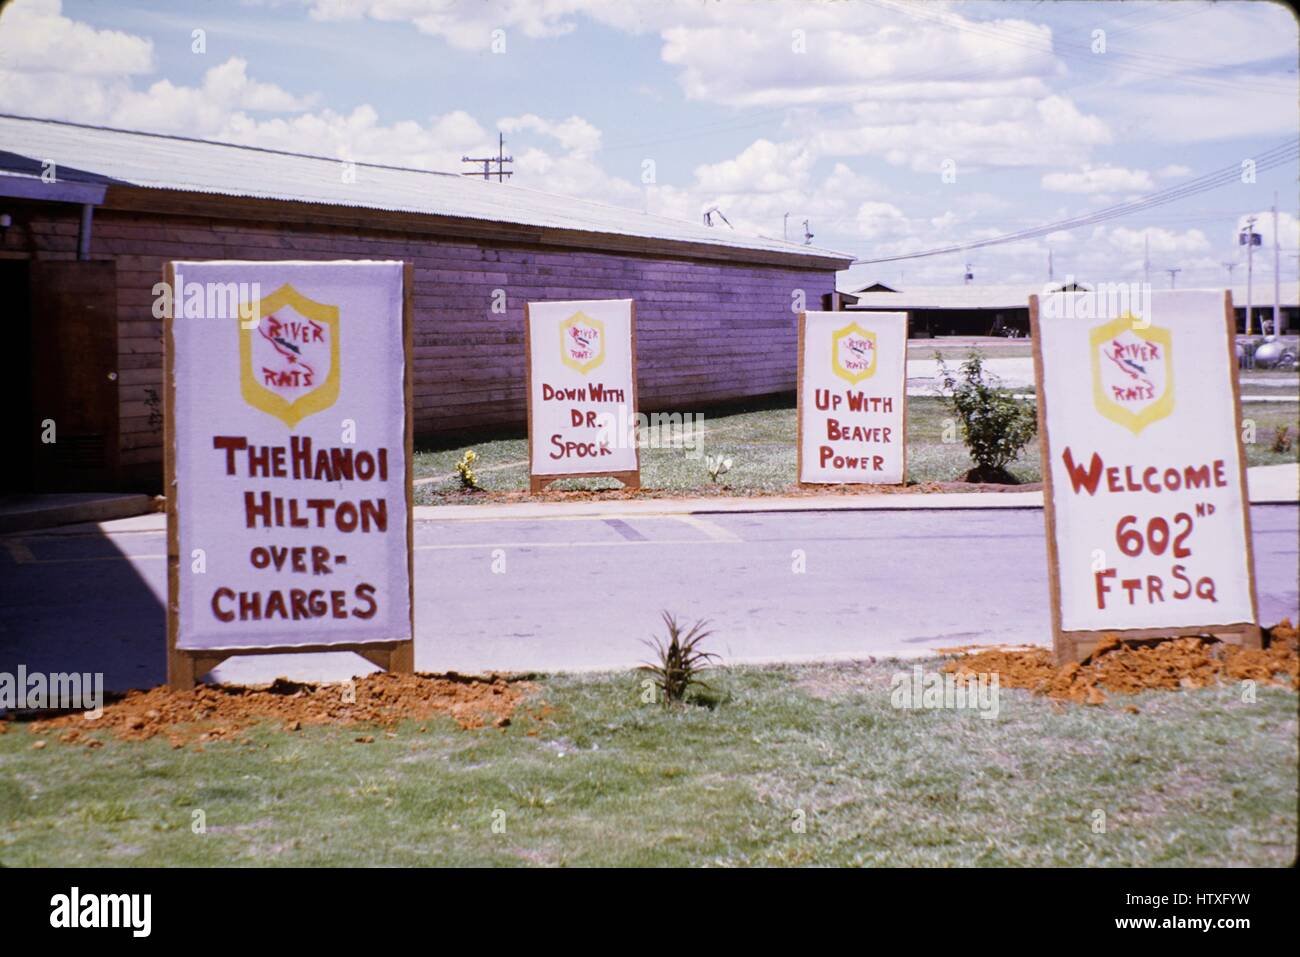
[1089,313,1174,436]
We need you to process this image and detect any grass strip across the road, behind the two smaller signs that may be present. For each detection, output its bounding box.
[415,397,1300,505]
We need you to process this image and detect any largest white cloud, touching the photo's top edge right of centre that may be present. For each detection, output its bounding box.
[301,0,1112,170]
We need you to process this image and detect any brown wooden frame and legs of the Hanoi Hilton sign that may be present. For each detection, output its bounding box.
[163,263,415,692]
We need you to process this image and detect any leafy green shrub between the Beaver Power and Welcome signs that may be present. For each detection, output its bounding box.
[935,352,1039,485]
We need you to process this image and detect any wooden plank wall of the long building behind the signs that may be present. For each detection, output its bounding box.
[0,207,835,480]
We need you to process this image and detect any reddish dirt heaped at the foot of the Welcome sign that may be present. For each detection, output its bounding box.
[944,619,1300,705]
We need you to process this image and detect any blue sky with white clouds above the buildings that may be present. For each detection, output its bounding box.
[0,0,1300,287]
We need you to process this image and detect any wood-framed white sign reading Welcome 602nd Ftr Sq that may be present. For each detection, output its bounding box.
[1030,291,1260,663]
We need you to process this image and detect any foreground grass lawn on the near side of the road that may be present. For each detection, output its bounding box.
[0,662,1297,867]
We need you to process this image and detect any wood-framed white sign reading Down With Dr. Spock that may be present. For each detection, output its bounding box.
[524,299,641,493]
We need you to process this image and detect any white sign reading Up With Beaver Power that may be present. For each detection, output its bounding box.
[798,312,907,485]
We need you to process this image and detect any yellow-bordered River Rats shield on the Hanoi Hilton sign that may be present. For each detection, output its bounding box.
[239,283,339,428]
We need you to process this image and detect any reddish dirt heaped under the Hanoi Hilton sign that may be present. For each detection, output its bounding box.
[33,672,533,746]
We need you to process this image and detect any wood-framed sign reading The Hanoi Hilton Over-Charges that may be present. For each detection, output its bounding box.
[163,261,415,689]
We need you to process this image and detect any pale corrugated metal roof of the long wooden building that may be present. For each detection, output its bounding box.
[0,114,853,264]
